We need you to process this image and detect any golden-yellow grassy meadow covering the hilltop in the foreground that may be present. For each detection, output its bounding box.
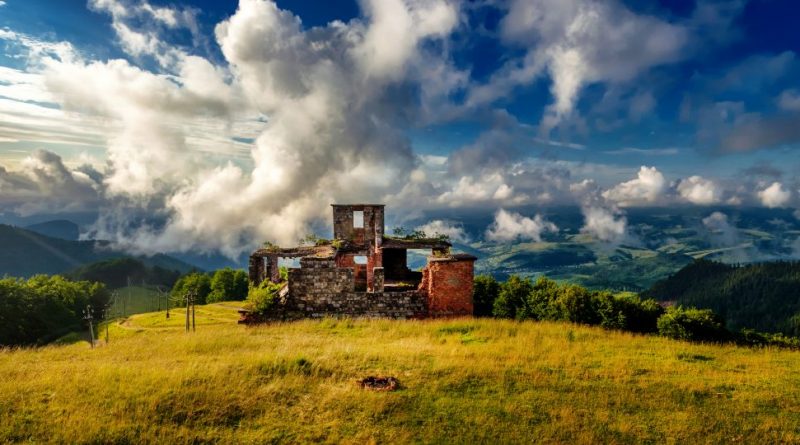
[0,303,800,443]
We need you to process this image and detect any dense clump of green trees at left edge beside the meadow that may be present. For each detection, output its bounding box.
[0,275,111,346]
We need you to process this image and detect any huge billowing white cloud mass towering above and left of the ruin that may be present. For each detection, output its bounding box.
[34,0,458,256]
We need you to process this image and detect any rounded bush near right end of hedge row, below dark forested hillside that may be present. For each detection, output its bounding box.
[658,306,729,342]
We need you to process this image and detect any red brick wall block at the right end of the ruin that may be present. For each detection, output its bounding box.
[423,259,474,317]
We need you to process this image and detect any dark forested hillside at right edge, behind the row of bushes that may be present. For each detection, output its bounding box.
[642,260,800,335]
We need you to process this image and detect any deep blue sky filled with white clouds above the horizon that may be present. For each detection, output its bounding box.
[0,0,800,252]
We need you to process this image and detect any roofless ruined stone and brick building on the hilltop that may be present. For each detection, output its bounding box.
[250,204,476,319]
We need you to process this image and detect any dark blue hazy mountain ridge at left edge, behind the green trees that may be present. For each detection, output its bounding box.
[0,224,197,277]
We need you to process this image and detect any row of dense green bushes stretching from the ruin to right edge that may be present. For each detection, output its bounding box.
[473,275,800,348]
